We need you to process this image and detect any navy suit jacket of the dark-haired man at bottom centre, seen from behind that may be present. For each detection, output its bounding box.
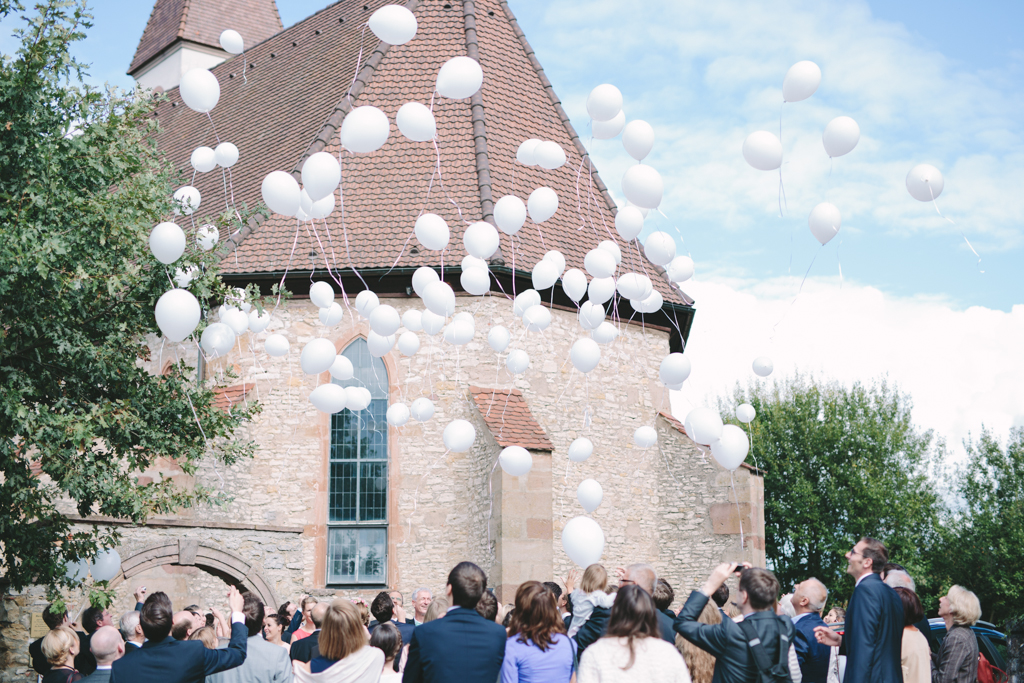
[402,607,507,683]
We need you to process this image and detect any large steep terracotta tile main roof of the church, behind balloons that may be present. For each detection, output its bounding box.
[149,0,692,304]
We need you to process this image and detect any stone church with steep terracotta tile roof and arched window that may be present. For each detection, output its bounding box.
[0,0,764,681]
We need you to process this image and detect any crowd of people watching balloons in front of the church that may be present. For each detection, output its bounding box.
[30,538,984,683]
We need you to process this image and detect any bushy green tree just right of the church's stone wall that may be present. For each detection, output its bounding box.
[721,375,940,603]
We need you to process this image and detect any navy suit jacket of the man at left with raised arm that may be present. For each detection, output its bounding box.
[111,624,249,683]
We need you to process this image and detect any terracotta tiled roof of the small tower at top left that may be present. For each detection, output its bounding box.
[128,0,283,74]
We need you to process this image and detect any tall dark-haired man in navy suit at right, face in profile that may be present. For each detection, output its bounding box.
[814,538,903,683]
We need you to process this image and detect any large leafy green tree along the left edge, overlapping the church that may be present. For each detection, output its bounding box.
[0,0,258,594]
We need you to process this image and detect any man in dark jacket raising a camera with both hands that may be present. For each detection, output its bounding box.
[675,562,793,683]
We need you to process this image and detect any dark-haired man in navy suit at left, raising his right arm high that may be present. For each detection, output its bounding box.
[111,586,249,683]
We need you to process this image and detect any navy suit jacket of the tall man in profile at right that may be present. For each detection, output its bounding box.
[840,573,903,683]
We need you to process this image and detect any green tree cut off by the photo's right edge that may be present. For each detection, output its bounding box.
[935,427,1024,625]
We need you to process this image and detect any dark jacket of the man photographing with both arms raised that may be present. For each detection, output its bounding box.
[675,591,794,683]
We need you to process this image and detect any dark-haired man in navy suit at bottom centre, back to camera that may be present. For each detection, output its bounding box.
[402,562,506,683]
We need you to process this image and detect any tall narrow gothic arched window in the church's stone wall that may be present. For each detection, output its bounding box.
[327,338,388,585]
